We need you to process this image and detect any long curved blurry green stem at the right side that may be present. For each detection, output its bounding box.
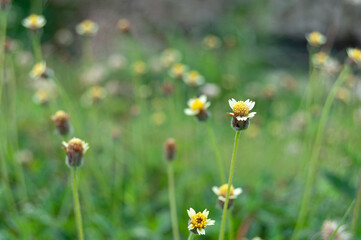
[292,65,350,240]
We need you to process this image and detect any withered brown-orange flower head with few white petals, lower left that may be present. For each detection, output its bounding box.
[63,138,89,168]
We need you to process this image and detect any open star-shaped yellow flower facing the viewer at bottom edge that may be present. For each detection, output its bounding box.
[187,208,216,235]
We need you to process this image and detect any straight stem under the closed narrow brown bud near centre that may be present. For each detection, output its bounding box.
[168,163,180,240]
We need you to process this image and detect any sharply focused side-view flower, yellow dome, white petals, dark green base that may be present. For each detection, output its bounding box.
[227,98,256,131]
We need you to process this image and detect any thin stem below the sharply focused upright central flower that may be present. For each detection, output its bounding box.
[219,131,241,240]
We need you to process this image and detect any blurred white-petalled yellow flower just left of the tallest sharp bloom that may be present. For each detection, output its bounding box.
[184,95,211,121]
